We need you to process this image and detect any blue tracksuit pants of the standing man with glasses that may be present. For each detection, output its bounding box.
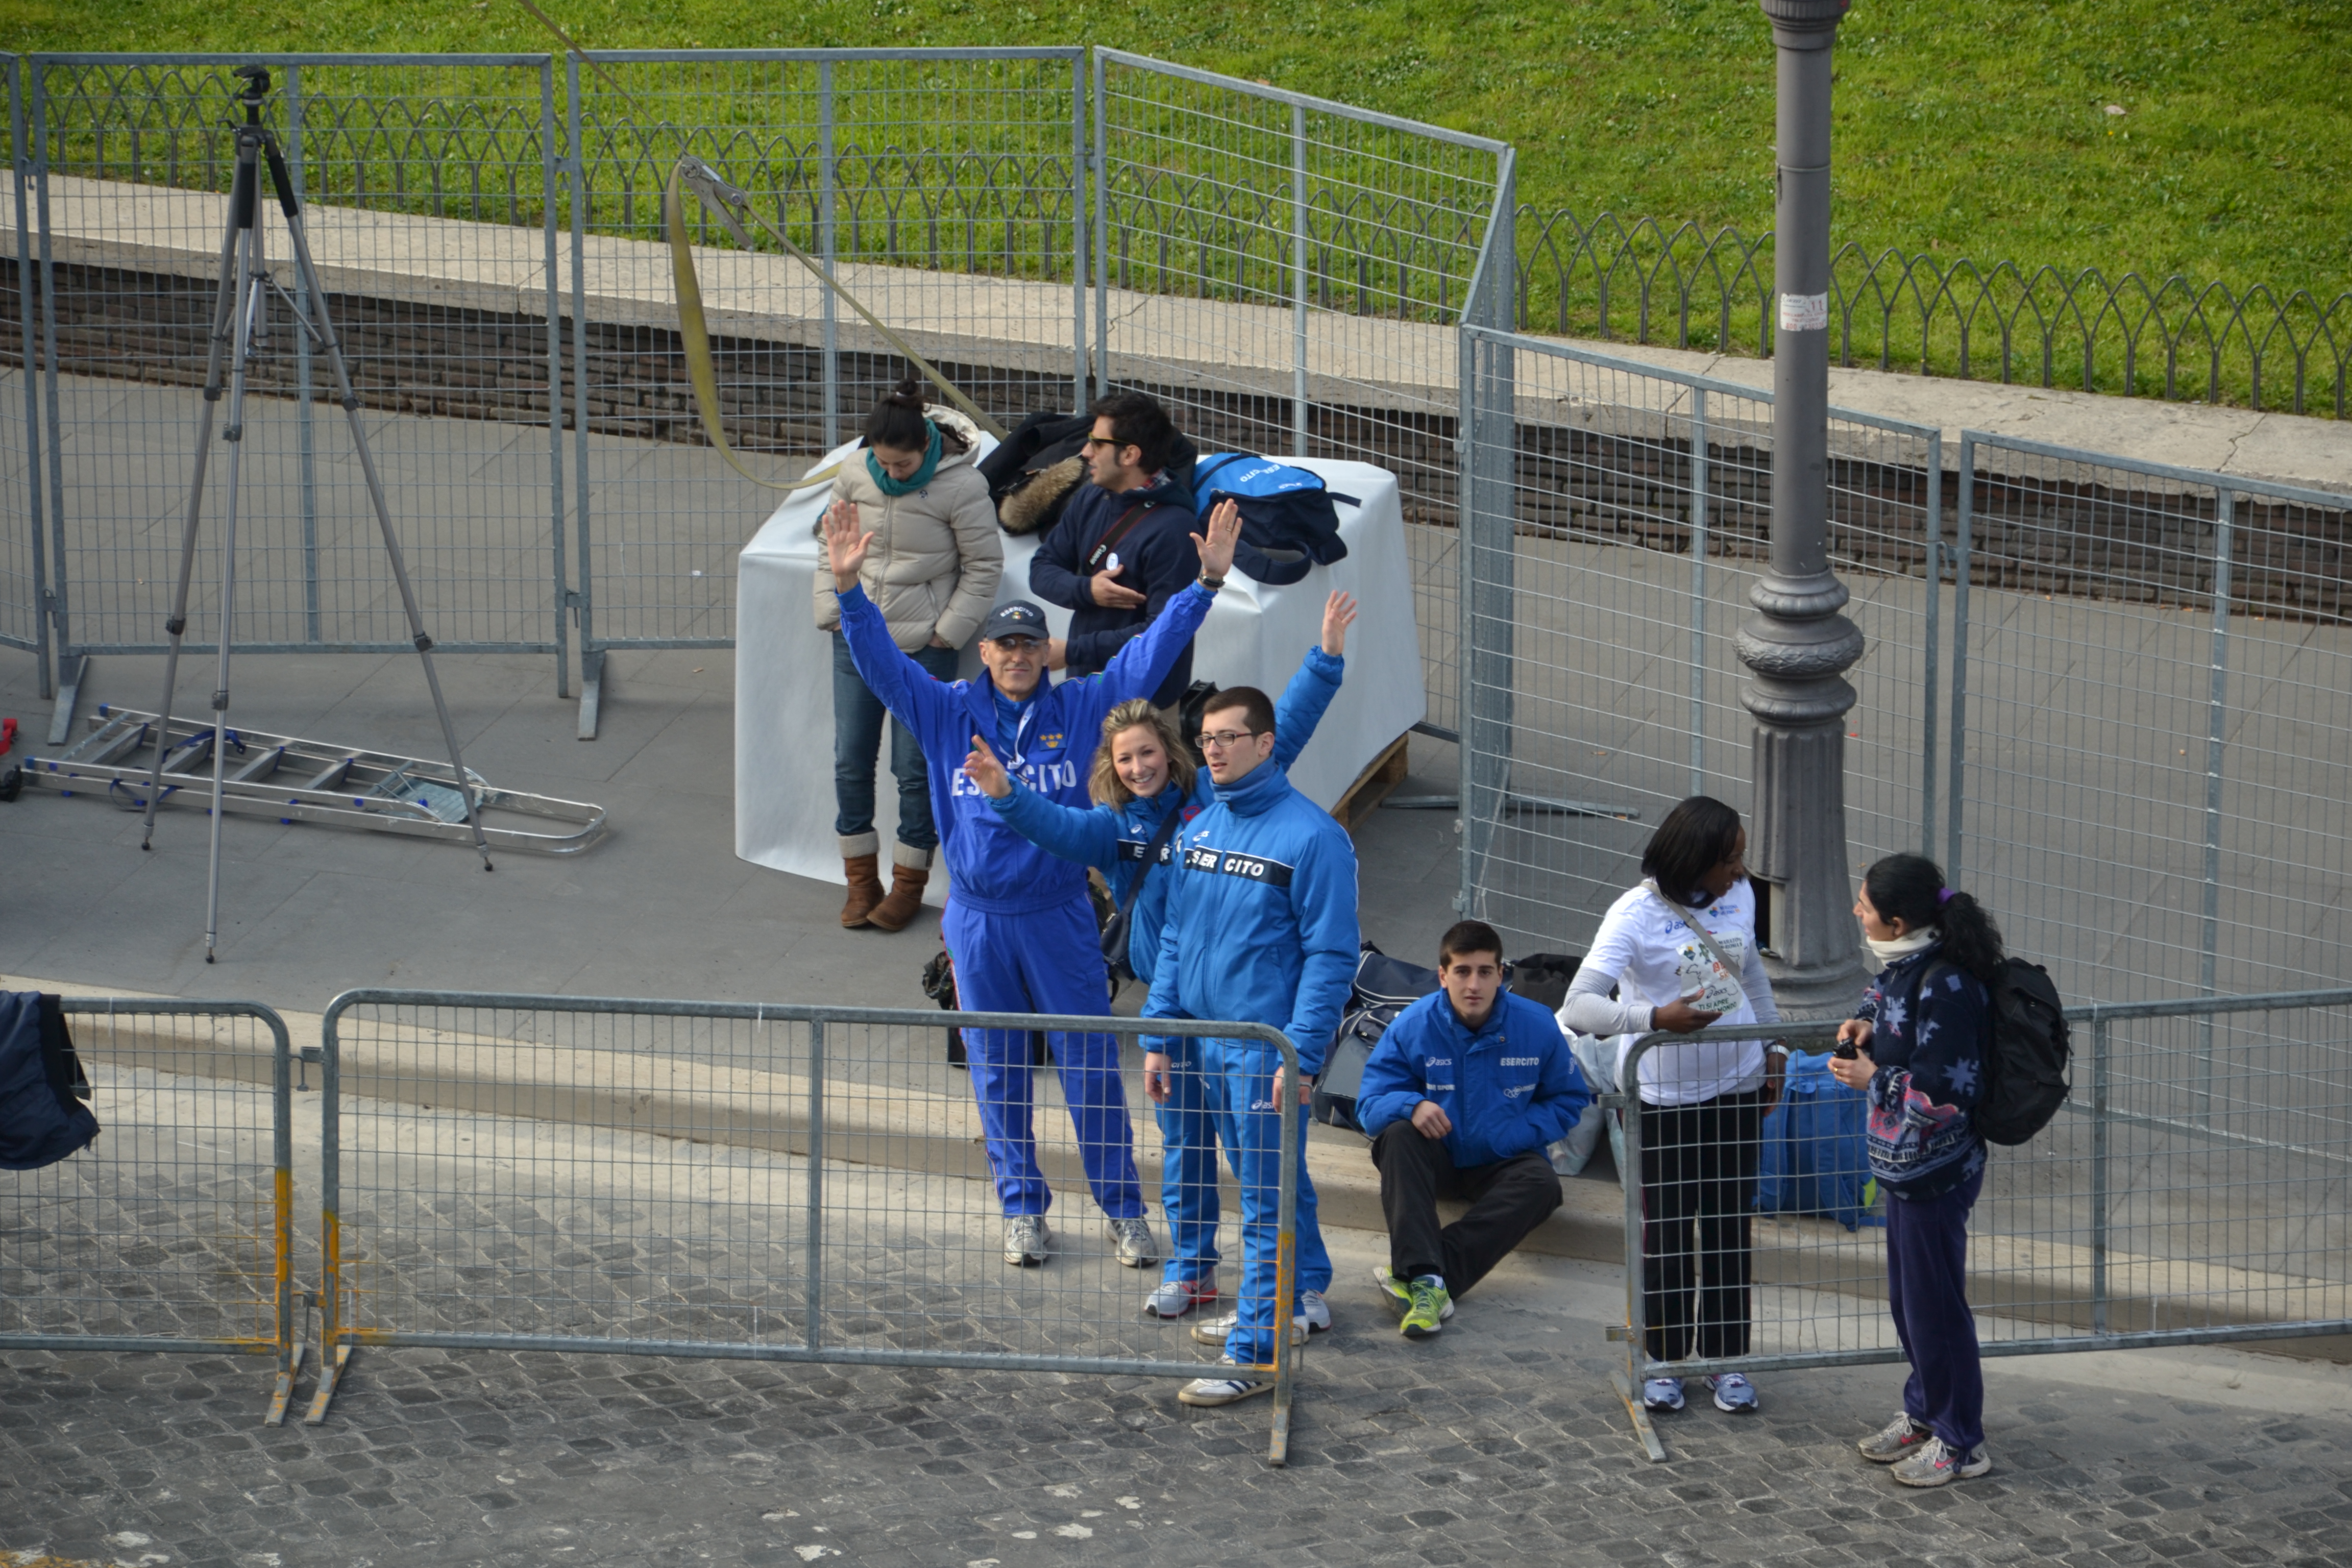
[1199,1039,1331,1366]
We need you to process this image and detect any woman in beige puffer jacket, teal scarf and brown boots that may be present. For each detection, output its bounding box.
[816,381,1004,931]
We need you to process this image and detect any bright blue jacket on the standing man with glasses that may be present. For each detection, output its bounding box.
[1143,764,1357,1074]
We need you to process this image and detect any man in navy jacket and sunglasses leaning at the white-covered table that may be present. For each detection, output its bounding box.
[1030,393,1197,707]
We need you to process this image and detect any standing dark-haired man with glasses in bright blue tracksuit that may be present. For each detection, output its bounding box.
[1143,687,1357,1406]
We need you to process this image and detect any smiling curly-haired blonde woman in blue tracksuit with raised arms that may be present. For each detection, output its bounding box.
[964,593,1355,1342]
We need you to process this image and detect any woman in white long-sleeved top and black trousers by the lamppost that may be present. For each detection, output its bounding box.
[1559,795,1787,1413]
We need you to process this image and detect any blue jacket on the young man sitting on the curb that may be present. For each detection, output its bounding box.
[1355,992,1592,1168]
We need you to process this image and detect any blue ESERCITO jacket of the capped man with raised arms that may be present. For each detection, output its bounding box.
[840,583,1213,921]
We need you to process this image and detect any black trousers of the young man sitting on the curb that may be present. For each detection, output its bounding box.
[1371,1121,1559,1295]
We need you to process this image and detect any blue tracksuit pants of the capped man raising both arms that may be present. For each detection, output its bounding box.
[941,893,1143,1220]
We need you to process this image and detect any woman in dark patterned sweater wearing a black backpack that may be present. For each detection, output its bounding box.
[1830,855,2004,1486]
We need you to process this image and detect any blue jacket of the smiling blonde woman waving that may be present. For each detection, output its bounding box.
[988,647,1345,985]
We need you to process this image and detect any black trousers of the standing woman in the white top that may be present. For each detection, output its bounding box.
[1641,1088,1764,1361]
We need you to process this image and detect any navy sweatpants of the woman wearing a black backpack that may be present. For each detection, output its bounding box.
[1886,1171,1985,1453]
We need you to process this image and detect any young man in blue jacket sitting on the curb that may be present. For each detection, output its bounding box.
[1355,919,1592,1340]
